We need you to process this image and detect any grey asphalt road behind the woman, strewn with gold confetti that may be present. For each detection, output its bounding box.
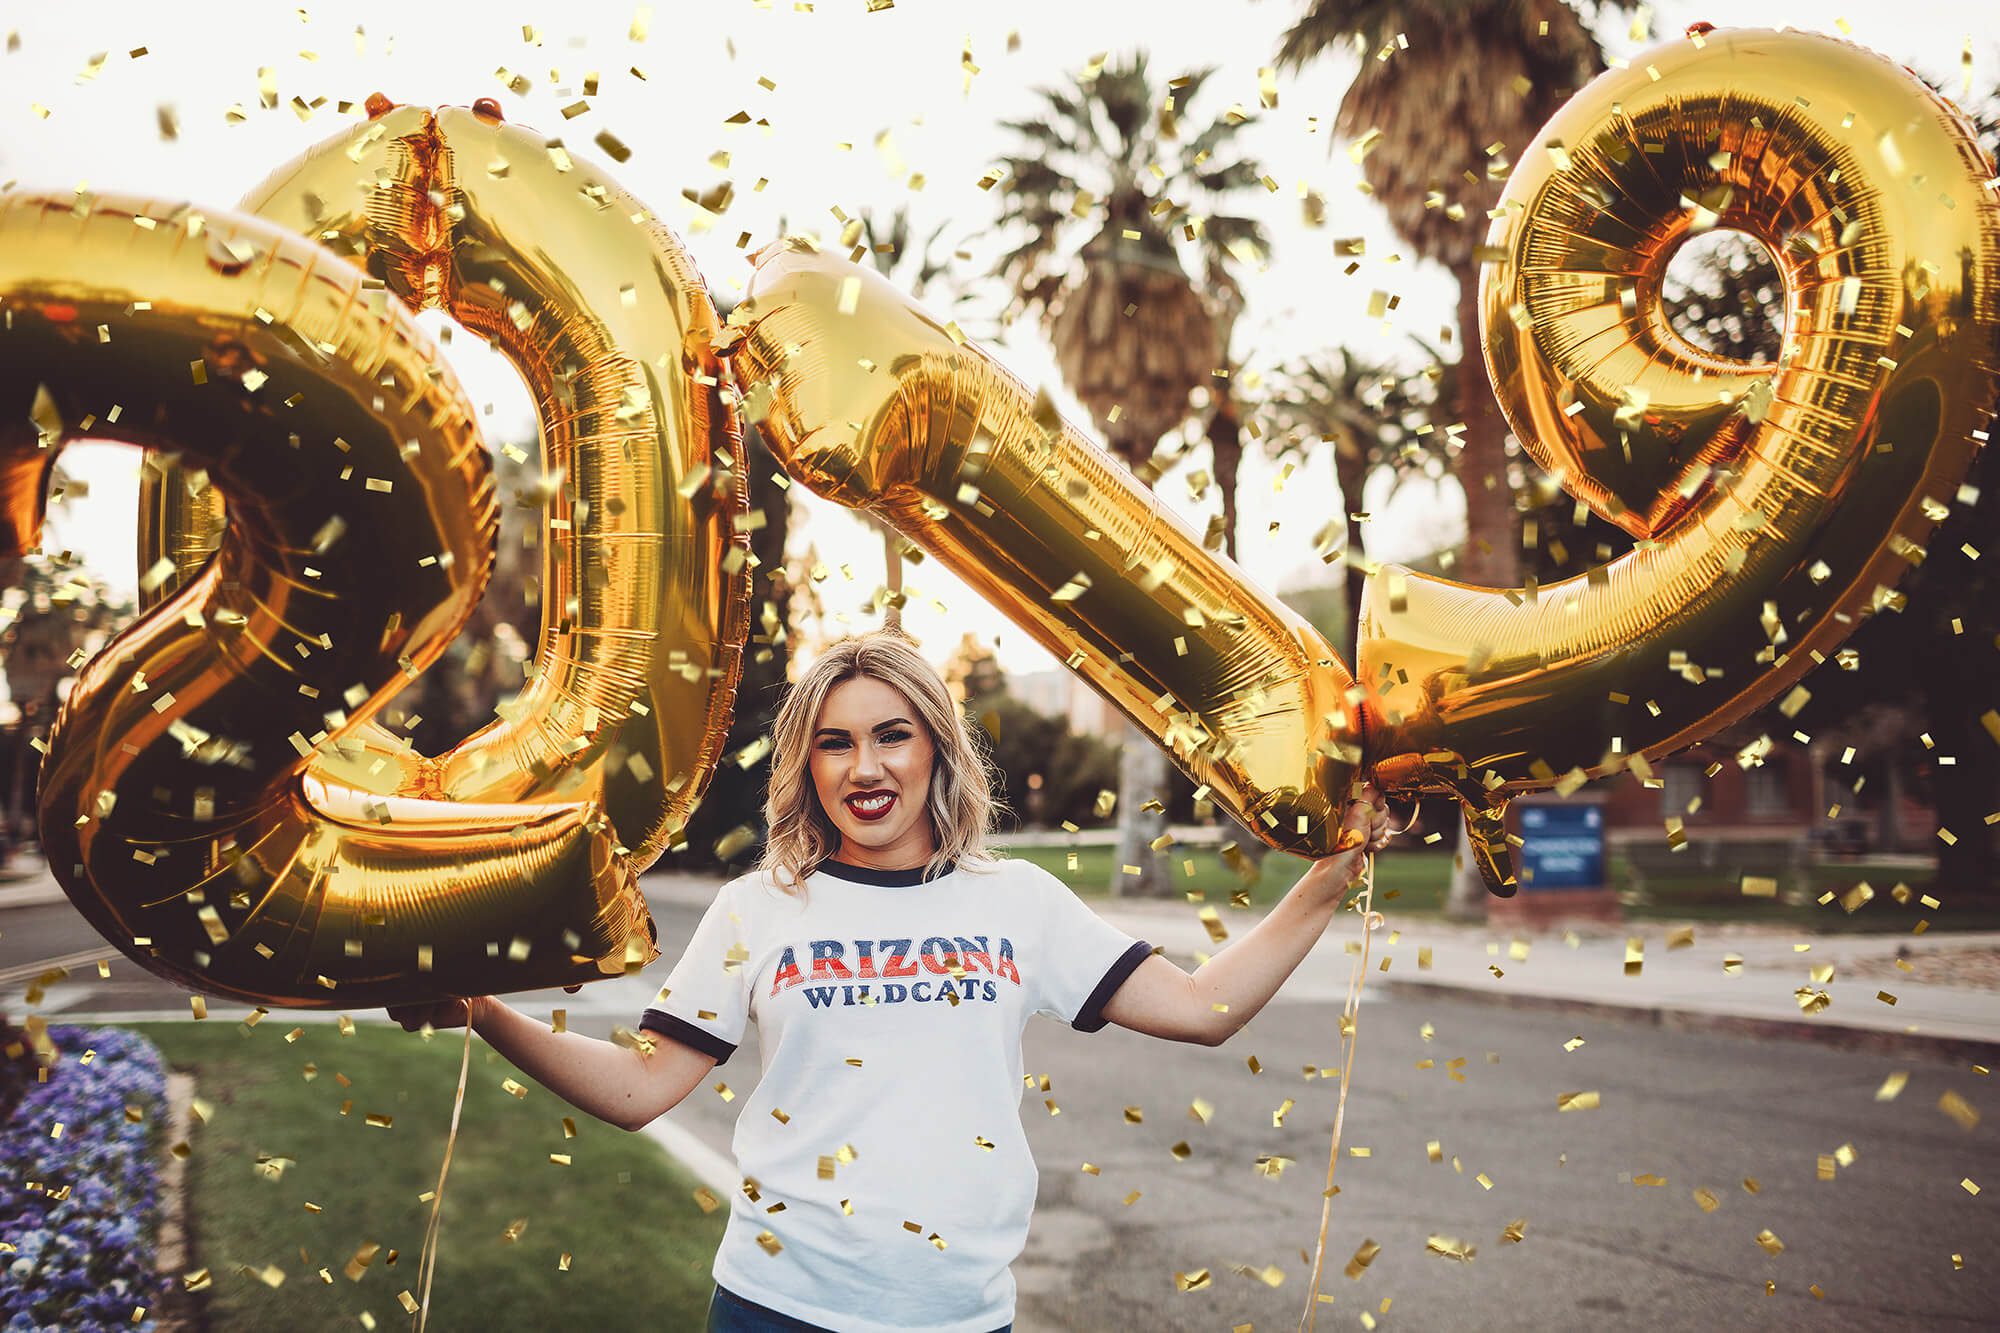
[0,876,2000,1333]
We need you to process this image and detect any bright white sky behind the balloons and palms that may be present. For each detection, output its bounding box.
[0,0,2000,673]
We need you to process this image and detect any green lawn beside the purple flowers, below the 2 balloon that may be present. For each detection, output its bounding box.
[134,1011,728,1333]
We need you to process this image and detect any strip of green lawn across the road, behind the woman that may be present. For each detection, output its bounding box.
[1008,847,2000,933]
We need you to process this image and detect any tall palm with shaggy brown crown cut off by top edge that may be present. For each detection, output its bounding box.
[1276,0,1636,917]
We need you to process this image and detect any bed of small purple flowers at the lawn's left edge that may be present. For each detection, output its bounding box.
[0,1027,166,1333]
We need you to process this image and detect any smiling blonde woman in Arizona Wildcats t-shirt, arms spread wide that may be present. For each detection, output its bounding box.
[390,632,1388,1333]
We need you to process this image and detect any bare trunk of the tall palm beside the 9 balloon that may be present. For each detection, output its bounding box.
[1444,264,1520,921]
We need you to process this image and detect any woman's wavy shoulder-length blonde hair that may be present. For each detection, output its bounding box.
[758,630,1002,895]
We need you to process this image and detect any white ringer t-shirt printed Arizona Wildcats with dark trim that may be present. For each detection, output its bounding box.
[640,861,1152,1333]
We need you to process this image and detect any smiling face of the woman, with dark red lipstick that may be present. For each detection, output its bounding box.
[812,677,938,871]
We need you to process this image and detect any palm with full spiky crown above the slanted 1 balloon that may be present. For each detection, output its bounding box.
[996,52,1266,895]
